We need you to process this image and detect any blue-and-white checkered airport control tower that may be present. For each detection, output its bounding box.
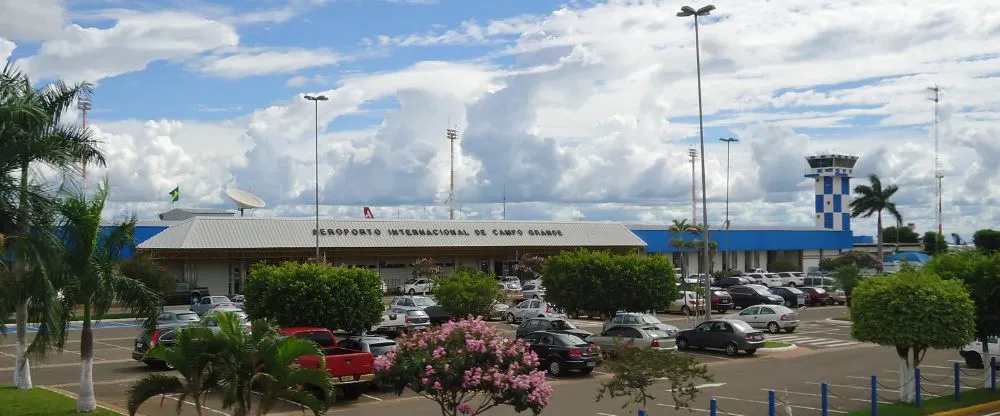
[805,154,858,231]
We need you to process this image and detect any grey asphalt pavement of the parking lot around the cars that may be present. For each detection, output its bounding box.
[13,306,982,416]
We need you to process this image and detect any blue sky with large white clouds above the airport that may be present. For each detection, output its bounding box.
[0,0,1000,240]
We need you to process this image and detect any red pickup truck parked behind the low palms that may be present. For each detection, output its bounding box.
[281,327,375,400]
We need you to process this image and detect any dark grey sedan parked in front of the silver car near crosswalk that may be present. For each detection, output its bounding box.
[677,319,764,355]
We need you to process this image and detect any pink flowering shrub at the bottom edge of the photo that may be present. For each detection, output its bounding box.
[375,316,552,416]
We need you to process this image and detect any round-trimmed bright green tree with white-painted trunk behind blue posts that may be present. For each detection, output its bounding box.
[850,269,976,402]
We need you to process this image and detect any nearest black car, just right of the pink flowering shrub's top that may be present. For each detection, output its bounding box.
[524,331,601,376]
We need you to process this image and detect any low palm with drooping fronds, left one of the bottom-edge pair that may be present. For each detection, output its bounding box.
[126,327,224,416]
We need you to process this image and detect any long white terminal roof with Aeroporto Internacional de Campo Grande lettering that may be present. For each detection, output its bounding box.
[139,217,646,250]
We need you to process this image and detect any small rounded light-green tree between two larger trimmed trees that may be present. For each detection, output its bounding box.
[434,269,503,316]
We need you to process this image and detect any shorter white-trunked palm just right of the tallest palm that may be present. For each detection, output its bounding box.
[59,184,162,412]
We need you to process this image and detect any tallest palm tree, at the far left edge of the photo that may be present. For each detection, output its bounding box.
[0,63,105,389]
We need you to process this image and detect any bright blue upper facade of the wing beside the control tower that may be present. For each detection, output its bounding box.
[630,226,854,253]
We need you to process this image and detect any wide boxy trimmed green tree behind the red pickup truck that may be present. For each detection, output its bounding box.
[244,262,385,333]
